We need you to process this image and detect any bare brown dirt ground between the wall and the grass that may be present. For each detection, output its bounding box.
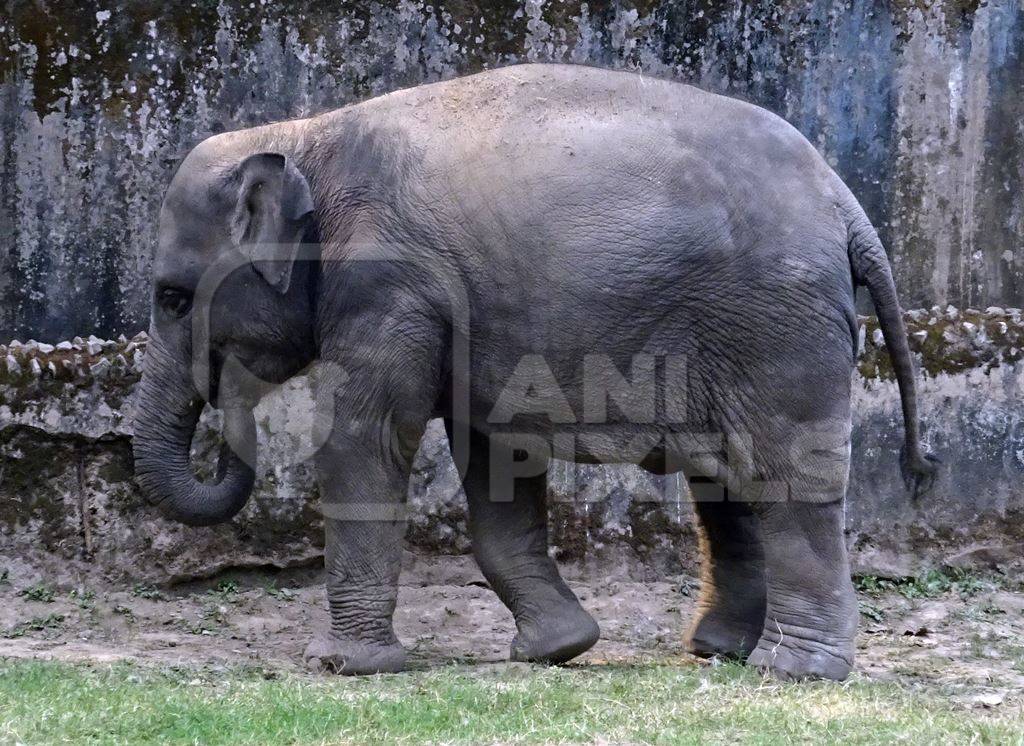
[0,557,1024,708]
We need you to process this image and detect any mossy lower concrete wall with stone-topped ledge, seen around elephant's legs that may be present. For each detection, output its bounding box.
[0,308,1024,581]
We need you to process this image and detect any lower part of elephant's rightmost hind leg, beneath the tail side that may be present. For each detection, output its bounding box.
[748,499,857,681]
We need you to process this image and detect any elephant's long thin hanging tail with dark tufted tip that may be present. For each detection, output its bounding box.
[843,192,939,497]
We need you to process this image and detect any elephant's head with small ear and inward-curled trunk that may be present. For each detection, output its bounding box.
[134,133,316,526]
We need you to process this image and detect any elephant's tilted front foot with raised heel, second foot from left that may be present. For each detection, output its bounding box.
[509,602,601,663]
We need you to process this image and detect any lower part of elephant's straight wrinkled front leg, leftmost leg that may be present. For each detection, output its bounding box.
[304,425,418,674]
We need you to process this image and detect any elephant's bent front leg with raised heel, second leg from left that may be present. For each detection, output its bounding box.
[449,421,600,663]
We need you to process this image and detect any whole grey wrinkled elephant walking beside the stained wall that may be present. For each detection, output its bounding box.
[133,63,937,679]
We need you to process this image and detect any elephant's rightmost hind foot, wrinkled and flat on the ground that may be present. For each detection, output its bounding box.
[746,624,853,682]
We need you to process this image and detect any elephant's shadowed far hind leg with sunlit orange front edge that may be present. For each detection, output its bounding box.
[686,480,766,658]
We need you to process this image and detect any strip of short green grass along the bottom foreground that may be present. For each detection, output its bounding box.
[0,660,1024,744]
